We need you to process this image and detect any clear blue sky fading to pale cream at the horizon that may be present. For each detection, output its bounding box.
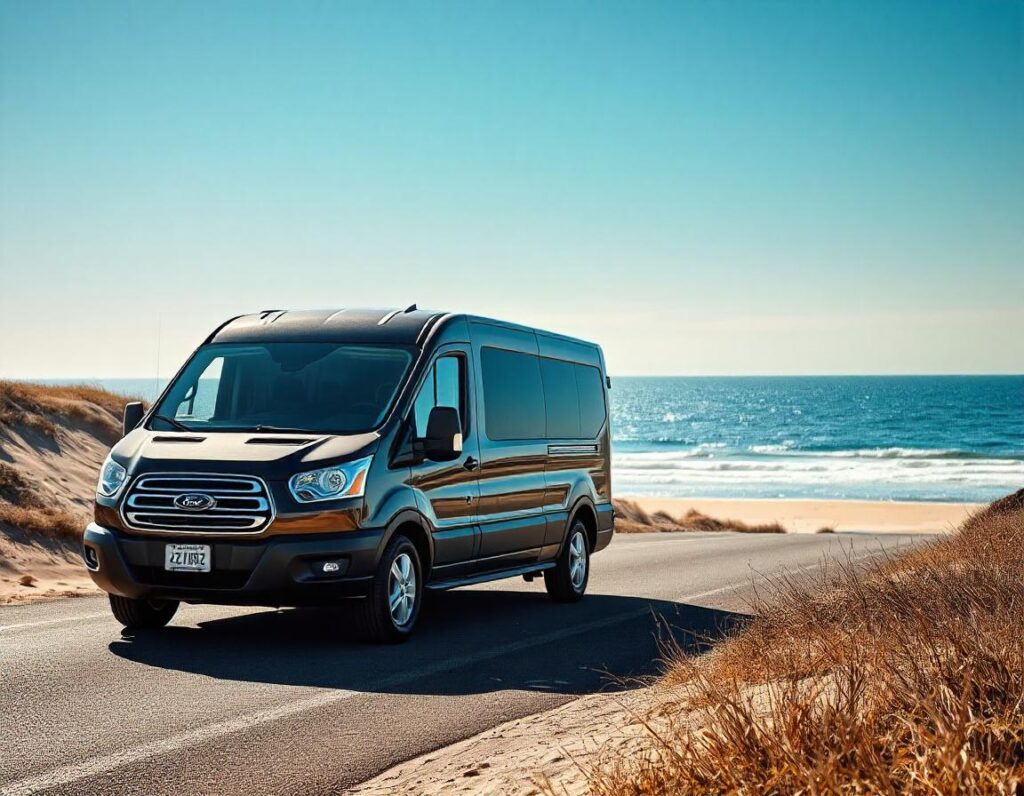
[0,0,1024,378]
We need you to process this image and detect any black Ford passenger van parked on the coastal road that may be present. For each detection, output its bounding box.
[83,305,613,641]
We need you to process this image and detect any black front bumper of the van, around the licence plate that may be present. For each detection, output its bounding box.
[83,522,384,606]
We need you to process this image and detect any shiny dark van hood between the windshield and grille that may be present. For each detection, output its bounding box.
[111,428,380,480]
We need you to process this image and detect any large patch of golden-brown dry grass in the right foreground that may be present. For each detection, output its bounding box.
[590,491,1024,796]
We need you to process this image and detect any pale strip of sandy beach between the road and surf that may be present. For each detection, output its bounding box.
[615,495,985,534]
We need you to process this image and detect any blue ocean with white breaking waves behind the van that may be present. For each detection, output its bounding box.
[39,376,1024,502]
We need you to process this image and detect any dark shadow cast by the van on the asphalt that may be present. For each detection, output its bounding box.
[110,590,745,695]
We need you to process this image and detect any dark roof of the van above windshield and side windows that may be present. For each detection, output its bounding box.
[206,304,594,345]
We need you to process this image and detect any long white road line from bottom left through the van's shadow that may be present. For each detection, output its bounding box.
[0,586,733,796]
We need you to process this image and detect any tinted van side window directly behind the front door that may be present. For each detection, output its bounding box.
[480,346,545,439]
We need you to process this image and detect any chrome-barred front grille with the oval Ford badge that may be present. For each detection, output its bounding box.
[121,473,273,534]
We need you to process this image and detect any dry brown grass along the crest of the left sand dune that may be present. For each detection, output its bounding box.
[0,380,137,444]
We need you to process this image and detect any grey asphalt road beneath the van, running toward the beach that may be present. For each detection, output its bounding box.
[0,534,923,796]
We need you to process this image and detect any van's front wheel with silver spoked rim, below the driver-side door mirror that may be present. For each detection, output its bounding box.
[356,534,423,644]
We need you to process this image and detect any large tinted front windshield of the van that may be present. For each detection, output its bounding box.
[151,342,413,434]
